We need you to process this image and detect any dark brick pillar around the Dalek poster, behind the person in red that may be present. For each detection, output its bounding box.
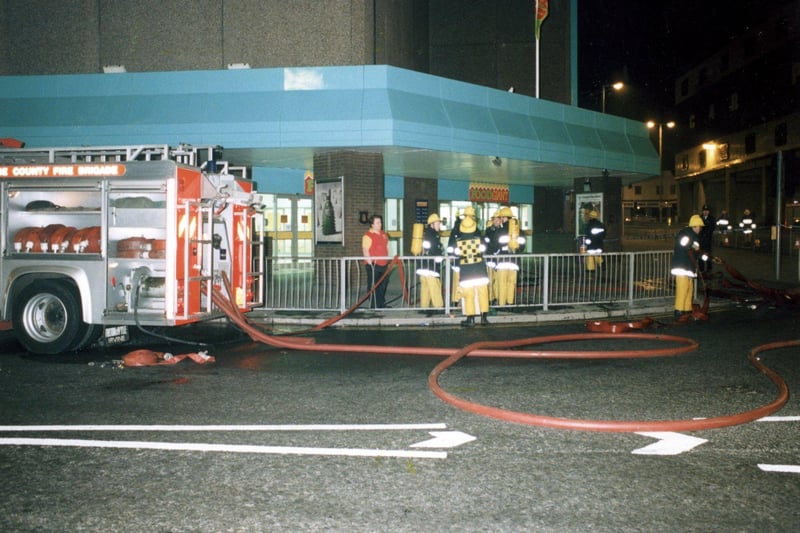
[314,150,385,257]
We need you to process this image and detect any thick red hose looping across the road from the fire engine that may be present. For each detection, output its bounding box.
[212,273,800,432]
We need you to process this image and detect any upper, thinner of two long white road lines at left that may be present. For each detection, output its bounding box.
[0,422,447,432]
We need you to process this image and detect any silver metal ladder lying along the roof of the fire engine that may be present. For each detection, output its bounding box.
[0,144,222,167]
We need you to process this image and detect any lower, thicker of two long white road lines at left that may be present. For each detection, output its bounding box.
[0,438,447,459]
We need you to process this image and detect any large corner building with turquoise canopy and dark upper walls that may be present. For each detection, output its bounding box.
[0,0,658,257]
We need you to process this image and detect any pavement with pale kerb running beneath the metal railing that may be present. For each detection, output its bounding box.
[255,239,800,330]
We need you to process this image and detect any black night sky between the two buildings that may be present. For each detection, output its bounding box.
[576,0,796,120]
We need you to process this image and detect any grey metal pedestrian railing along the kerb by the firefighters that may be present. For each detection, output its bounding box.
[264,251,674,313]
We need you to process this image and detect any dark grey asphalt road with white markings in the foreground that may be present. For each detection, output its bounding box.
[0,309,800,532]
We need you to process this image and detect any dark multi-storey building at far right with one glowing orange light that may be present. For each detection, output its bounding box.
[674,1,800,225]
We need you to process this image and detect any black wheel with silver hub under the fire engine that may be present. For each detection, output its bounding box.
[12,280,86,354]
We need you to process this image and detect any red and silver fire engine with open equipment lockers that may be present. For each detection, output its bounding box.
[0,145,264,354]
